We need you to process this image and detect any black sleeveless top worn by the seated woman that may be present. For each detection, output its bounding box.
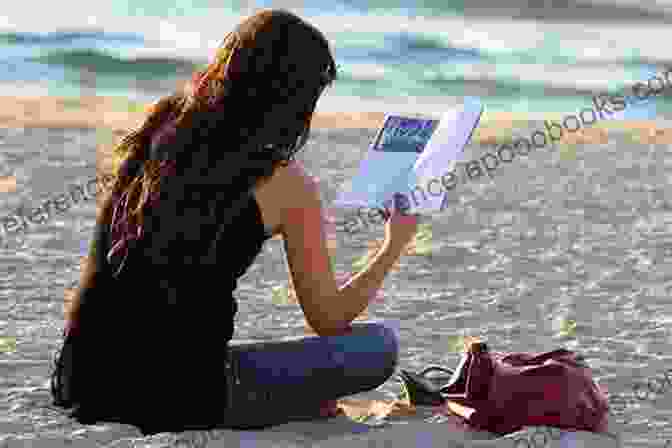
[75,188,271,432]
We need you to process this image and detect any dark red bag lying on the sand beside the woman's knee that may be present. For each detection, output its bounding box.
[402,342,609,434]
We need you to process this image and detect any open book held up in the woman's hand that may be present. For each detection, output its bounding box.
[333,98,483,214]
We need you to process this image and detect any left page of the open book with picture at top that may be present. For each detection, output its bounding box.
[334,114,439,208]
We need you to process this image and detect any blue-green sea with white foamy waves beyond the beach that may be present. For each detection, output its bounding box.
[0,0,672,117]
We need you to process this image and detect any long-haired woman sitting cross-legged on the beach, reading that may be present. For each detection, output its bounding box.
[55,10,417,434]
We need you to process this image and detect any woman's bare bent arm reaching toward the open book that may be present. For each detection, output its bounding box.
[274,165,403,336]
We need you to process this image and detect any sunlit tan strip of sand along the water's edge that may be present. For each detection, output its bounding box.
[0,95,672,180]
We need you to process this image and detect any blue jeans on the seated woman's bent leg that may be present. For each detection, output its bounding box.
[223,322,399,429]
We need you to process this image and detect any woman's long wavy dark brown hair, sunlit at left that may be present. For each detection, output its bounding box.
[112,9,337,272]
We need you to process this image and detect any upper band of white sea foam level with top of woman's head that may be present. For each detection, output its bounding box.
[0,5,669,67]
